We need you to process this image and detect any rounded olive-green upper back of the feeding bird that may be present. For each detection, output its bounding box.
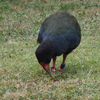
[38,12,81,43]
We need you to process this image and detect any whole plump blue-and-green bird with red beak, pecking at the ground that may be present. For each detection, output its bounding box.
[35,11,81,73]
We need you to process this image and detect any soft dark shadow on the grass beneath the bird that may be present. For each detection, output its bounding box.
[37,63,88,82]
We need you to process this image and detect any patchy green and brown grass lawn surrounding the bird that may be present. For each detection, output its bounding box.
[0,0,100,100]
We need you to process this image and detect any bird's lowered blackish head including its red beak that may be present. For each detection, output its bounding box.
[35,40,53,73]
